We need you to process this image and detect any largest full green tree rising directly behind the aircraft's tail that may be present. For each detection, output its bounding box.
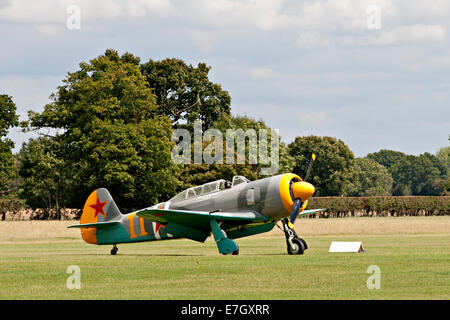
[25,50,178,210]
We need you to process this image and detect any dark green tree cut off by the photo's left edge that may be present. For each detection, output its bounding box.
[0,94,19,196]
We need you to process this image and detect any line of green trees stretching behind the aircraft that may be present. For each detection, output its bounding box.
[0,49,450,218]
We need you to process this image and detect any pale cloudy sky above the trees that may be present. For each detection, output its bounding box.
[0,0,450,156]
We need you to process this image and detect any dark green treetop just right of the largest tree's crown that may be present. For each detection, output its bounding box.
[141,58,231,129]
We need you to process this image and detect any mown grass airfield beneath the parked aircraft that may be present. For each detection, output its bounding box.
[0,216,450,300]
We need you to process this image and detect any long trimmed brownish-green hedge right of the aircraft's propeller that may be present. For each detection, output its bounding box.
[308,196,450,217]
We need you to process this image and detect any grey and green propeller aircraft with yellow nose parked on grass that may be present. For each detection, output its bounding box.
[69,154,326,255]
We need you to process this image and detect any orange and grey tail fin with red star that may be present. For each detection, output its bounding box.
[77,188,122,244]
